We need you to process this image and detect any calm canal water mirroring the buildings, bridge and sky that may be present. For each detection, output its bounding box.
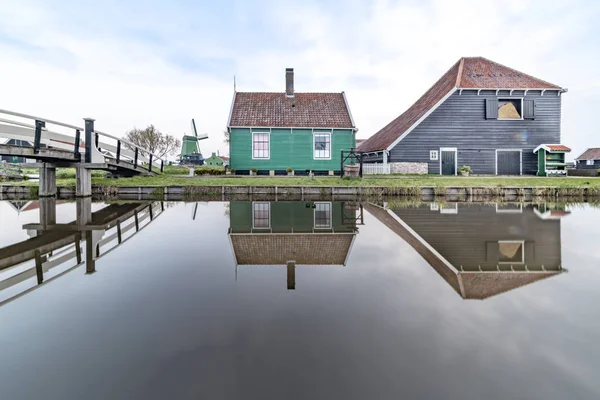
[0,201,600,399]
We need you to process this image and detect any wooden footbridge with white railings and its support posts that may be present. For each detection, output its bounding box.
[0,110,164,197]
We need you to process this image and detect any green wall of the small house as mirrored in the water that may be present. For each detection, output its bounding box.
[229,201,356,233]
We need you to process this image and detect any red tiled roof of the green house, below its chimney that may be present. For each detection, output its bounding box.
[229,92,354,128]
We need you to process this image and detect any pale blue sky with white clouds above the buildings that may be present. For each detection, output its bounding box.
[0,0,600,156]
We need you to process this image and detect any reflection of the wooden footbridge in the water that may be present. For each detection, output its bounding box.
[0,197,164,305]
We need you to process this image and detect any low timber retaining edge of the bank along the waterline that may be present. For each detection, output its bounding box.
[0,185,600,199]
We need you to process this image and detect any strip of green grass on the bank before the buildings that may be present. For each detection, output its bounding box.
[8,170,600,192]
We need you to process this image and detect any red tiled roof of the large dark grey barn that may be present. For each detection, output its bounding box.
[358,57,561,152]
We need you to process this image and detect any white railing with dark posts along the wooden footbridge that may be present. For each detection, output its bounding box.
[0,109,165,172]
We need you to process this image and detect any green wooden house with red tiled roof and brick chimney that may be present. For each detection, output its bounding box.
[227,68,357,175]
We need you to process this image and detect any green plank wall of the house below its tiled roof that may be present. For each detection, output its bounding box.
[229,128,356,171]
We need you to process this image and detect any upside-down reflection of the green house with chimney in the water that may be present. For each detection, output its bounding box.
[229,201,361,289]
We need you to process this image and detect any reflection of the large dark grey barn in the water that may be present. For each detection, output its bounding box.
[365,203,563,299]
